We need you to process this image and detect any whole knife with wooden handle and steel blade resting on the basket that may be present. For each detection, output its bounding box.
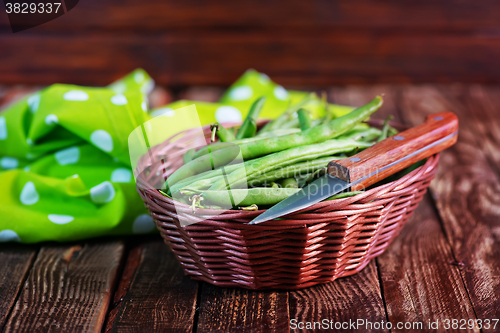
[249,112,458,224]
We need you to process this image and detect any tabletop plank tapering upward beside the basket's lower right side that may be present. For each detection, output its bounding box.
[377,196,479,332]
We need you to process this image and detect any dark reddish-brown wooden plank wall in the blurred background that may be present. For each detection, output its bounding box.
[0,0,500,88]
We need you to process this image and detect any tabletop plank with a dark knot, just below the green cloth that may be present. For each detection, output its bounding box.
[5,241,123,332]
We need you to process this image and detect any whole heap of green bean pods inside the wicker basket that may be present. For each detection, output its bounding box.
[162,94,395,210]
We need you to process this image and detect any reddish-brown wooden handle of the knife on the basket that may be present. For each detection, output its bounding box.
[328,112,458,191]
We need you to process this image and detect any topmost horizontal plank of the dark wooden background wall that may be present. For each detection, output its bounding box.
[0,0,500,33]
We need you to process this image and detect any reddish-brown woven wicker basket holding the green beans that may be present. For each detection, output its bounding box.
[137,120,438,289]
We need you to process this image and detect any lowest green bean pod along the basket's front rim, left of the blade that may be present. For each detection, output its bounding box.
[202,187,300,206]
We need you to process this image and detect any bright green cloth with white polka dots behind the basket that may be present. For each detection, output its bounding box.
[0,69,352,243]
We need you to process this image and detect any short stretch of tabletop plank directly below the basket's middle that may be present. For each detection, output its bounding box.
[196,283,290,332]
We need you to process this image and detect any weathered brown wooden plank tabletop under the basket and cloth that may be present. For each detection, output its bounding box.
[0,85,500,332]
